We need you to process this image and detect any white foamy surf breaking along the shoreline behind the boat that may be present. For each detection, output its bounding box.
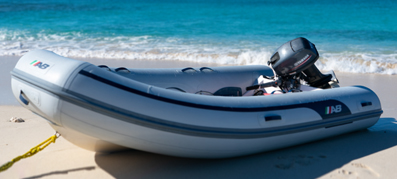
[0,30,397,75]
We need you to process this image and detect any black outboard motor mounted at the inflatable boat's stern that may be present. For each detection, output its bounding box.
[268,37,332,92]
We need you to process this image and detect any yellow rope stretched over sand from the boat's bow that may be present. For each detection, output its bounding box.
[0,132,61,172]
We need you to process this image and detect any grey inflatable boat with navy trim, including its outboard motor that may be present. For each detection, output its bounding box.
[11,38,382,158]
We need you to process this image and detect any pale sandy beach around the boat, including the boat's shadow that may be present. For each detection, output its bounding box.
[0,56,397,178]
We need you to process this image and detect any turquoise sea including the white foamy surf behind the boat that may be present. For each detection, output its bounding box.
[0,0,397,74]
